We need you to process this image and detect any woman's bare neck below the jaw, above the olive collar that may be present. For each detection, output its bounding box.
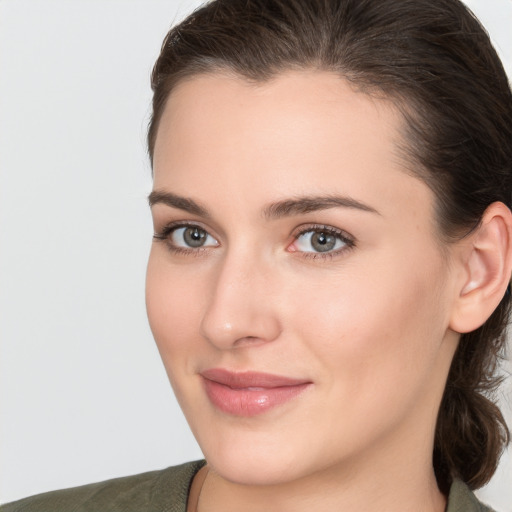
[198,410,446,512]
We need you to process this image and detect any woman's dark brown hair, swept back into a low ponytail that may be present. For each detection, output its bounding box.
[148,0,512,492]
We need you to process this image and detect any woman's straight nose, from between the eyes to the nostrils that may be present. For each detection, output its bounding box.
[201,248,281,350]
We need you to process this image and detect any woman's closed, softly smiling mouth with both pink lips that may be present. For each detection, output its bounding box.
[201,368,313,417]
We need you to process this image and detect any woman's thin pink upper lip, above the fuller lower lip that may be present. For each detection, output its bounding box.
[201,368,311,389]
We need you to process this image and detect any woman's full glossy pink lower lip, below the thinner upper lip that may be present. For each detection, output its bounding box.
[203,379,311,417]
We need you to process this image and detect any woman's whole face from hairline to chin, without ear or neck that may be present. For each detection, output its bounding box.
[147,71,458,484]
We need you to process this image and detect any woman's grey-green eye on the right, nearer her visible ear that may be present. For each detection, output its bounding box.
[290,226,354,254]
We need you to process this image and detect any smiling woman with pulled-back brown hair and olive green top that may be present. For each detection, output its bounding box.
[5,0,512,512]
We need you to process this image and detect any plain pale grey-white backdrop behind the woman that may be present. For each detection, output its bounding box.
[0,0,512,512]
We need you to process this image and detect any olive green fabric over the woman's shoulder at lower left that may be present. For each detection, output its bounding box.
[0,461,205,512]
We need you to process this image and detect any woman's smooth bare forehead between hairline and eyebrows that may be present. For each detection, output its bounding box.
[154,71,431,228]
